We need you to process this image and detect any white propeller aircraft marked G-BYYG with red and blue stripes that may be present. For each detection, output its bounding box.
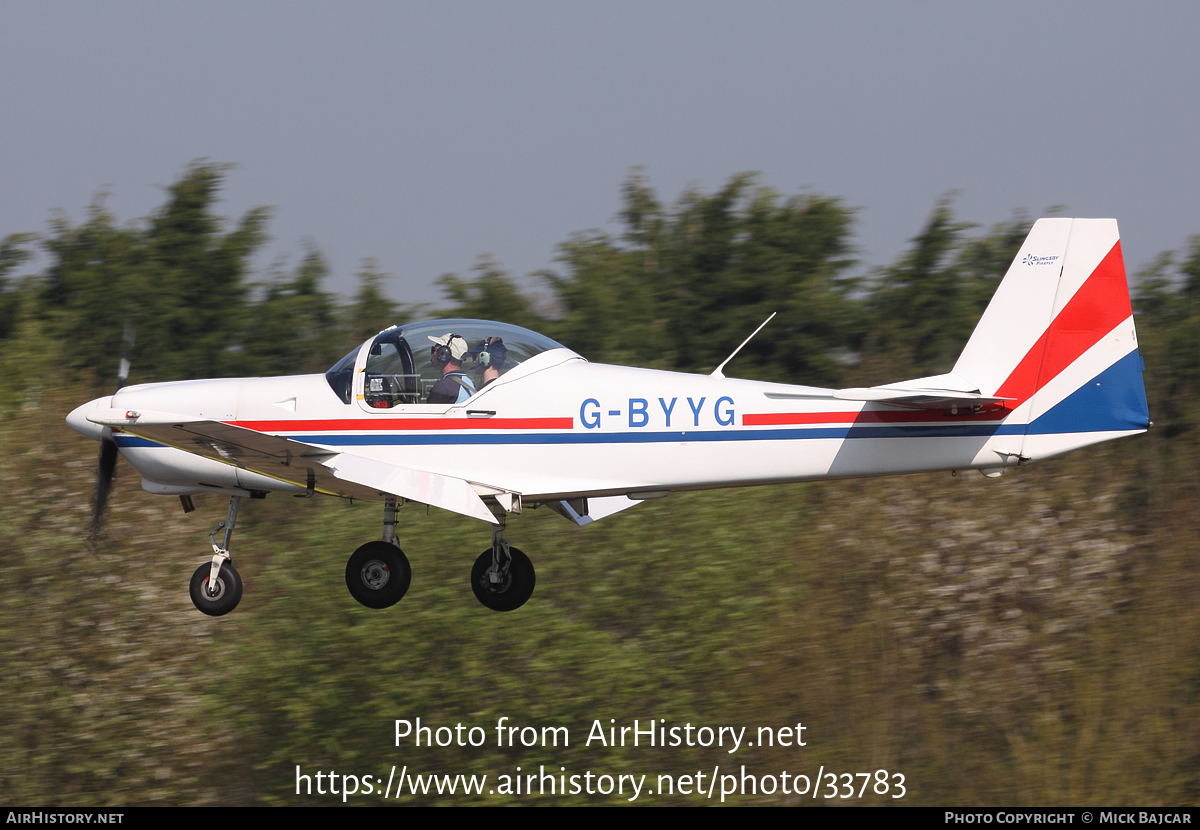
[67,218,1150,615]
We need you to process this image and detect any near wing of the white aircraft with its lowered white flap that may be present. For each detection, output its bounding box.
[88,409,496,524]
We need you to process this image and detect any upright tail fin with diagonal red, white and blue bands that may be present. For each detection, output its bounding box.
[954,218,1150,458]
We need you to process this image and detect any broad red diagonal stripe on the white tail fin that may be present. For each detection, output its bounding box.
[996,240,1133,407]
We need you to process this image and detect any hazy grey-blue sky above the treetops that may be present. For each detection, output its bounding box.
[0,0,1200,301]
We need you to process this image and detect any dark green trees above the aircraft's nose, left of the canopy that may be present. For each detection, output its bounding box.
[0,164,406,385]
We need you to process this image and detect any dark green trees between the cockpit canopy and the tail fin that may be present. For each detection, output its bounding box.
[422,172,1031,385]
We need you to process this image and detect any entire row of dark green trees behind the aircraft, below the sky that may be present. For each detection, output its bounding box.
[0,163,1200,407]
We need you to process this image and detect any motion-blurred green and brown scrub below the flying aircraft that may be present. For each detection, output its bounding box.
[0,393,1200,806]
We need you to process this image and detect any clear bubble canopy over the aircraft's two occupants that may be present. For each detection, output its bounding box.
[325,318,565,409]
